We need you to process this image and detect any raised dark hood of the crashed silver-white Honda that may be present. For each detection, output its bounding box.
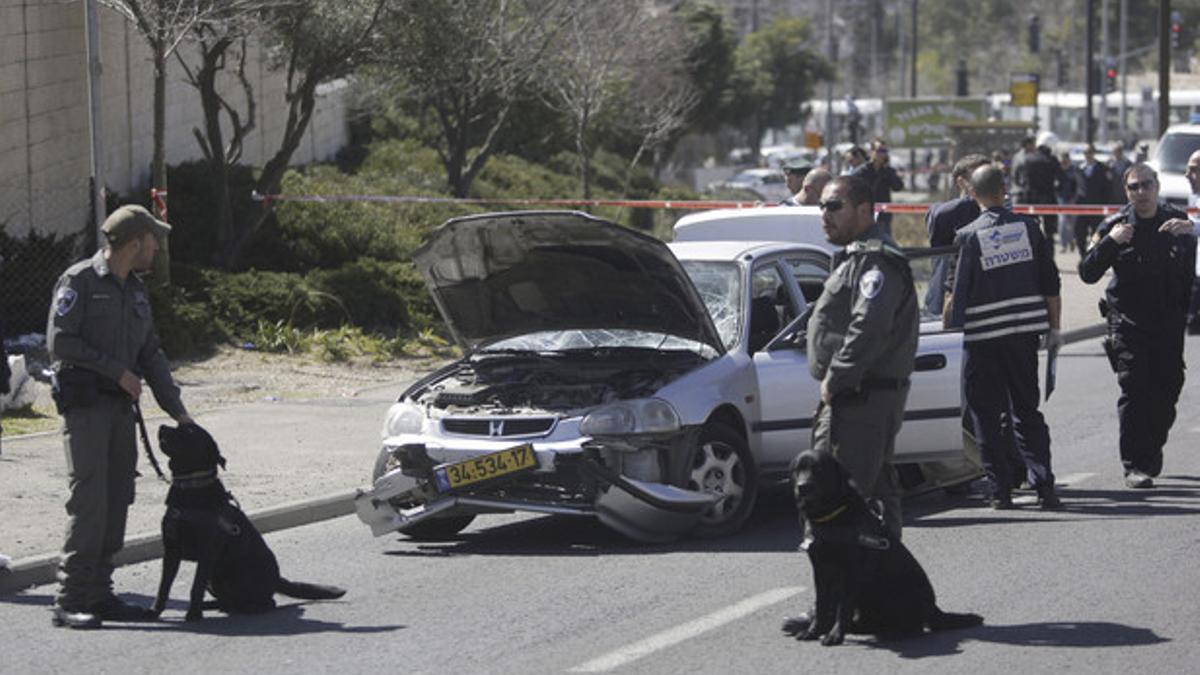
[413,211,725,353]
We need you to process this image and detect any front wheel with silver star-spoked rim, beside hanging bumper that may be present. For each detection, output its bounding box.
[685,422,758,537]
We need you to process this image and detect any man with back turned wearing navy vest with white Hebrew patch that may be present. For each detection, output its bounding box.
[948,165,1062,509]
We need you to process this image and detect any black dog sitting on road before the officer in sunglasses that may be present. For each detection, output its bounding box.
[784,450,983,646]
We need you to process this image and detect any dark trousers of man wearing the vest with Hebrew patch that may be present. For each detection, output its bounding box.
[962,333,1054,494]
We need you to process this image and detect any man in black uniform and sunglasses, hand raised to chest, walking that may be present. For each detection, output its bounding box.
[1079,163,1196,488]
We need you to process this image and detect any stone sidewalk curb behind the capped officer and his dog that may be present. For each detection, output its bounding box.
[0,491,354,595]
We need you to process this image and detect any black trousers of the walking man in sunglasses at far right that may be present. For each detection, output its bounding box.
[1109,319,1184,476]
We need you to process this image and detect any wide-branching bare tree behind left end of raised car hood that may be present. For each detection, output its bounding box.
[372,0,560,197]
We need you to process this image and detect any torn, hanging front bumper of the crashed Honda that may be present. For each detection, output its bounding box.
[354,443,715,542]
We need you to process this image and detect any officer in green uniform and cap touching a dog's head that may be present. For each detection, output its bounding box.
[46,205,193,628]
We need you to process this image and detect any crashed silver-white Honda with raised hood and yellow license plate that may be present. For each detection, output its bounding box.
[355,208,978,542]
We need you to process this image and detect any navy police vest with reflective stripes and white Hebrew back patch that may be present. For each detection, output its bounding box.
[961,211,1050,342]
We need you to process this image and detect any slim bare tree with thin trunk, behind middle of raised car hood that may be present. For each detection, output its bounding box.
[545,0,653,198]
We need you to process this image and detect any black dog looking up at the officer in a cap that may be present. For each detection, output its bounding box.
[152,424,346,621]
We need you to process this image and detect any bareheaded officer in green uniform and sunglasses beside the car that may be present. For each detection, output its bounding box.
[808,177,920,538]
